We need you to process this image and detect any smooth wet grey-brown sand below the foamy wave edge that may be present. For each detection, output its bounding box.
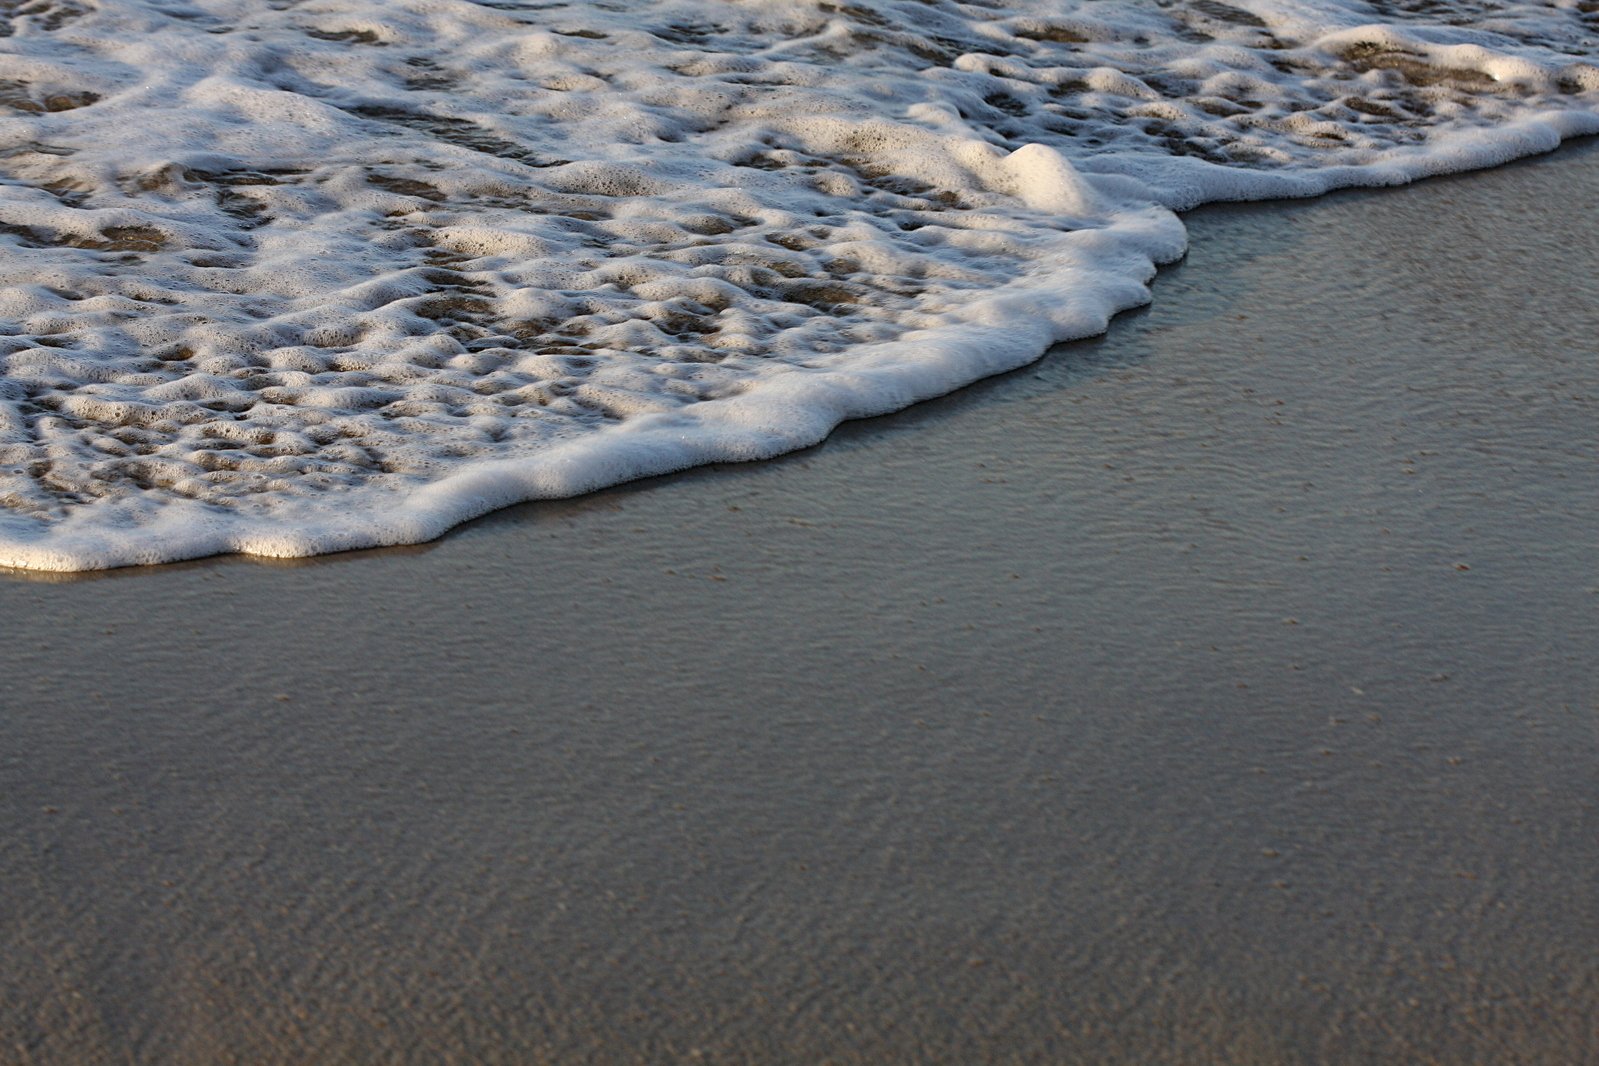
[0,145,1599,1064]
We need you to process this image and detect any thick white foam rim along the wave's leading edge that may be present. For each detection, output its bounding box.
[0,127,1599,574]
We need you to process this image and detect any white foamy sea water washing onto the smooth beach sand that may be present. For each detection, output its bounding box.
[0,0,1599,569]
